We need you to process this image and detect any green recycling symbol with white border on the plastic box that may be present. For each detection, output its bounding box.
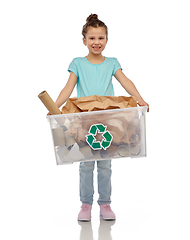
[85,123,113,150]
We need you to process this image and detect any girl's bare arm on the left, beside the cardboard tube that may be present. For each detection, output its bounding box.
[55,72,77,108]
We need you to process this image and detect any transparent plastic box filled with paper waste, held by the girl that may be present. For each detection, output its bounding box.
[47,107,147,165]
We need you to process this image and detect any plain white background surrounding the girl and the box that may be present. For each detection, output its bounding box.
[0,0,190,240]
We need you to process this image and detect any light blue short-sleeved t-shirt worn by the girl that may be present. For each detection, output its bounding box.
[68,57,121,97]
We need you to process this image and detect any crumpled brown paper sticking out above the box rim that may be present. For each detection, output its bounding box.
[62,95,137,114]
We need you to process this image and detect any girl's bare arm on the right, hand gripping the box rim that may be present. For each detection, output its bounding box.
[115,69,149,112]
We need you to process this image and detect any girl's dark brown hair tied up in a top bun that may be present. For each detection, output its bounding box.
[82,14,108,38]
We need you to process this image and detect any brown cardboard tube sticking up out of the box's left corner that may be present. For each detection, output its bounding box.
[38,91,61,115]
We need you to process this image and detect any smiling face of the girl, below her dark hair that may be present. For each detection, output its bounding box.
[83,27,108,55]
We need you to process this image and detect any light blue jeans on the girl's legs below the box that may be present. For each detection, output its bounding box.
[80,160,112,205]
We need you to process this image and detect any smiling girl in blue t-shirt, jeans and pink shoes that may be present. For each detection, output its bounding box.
[56,14,149,221]
